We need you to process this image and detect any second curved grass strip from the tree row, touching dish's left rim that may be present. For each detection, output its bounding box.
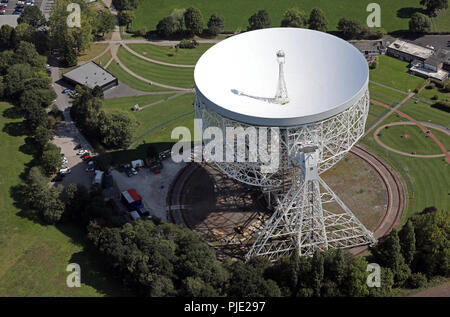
[117,47,194,88]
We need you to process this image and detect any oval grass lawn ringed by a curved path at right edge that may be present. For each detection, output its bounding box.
[380,125,450,155]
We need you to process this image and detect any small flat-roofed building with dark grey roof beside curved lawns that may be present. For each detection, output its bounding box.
[63,62,119,91]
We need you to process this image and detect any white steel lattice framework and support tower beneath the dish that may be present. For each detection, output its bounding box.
[195,88,376,259]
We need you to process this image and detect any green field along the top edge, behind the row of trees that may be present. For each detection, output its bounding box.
[133,0,434,32]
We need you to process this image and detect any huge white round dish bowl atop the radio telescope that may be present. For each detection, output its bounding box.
[194,28,369,127]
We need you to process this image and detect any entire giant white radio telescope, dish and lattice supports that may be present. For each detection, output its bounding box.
[194,28,376,260]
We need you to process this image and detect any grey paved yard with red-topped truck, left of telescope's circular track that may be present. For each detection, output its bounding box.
[111,158,186,221]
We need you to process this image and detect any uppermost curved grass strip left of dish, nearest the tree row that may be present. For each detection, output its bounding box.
[128,44,214,65]
